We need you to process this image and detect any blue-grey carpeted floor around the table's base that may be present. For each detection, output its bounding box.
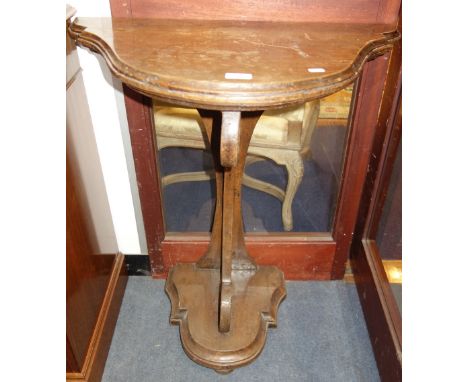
[103,276,380,382]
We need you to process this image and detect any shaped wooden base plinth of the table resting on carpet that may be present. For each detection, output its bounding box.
[166,263,286,374]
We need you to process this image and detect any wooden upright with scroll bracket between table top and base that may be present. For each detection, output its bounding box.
[197,110,262,332]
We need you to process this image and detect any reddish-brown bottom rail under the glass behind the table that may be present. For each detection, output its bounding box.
[163,235,336,280]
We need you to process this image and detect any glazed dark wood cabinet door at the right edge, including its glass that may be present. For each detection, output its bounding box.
[351,35,402,381]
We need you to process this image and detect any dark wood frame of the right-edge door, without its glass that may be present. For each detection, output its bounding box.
[350,15,402,381]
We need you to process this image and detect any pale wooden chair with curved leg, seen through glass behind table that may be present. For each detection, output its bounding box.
[153,100,320,231]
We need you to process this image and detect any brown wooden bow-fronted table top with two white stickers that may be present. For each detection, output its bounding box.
[69,17,399,110]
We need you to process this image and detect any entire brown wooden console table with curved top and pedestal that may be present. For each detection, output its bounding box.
[68,18,399,373]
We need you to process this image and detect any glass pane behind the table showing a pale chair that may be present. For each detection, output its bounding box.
[154,86,353,232]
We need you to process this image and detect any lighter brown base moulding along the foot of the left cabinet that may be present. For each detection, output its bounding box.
[66,254,127,382]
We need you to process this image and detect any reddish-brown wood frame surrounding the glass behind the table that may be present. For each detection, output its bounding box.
[111,0,400,280]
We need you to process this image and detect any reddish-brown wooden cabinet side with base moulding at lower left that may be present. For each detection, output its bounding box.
[66,160,127,382]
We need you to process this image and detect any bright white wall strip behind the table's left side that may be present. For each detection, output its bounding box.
[69,0,147,254]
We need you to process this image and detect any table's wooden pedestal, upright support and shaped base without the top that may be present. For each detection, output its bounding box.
[166,109,286,373]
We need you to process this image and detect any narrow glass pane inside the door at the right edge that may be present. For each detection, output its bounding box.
[376,140,402,313]
